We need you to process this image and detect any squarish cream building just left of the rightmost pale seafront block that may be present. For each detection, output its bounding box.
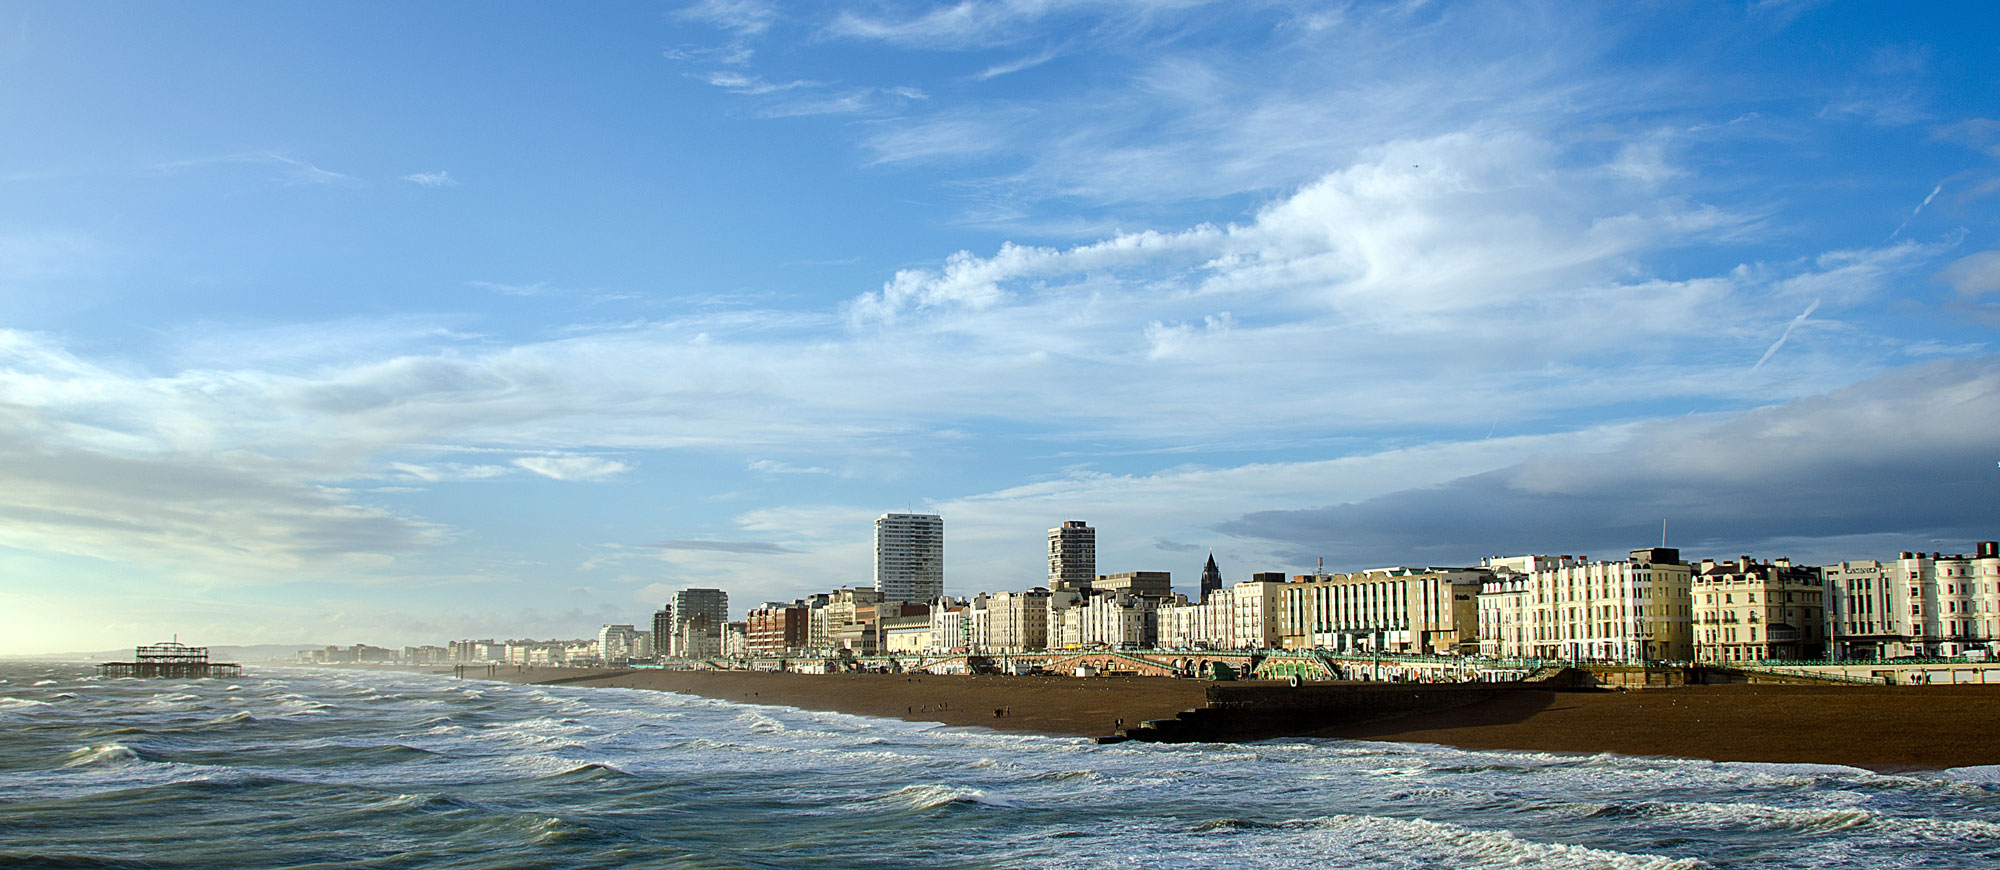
[1692,556,1826,664]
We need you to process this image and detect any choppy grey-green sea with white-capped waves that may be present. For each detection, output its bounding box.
[0,662,2000,870]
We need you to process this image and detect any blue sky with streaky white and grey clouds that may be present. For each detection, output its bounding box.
[0,0,2000,654]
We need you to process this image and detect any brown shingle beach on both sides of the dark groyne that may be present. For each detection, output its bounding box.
[446,668,2000,770]
